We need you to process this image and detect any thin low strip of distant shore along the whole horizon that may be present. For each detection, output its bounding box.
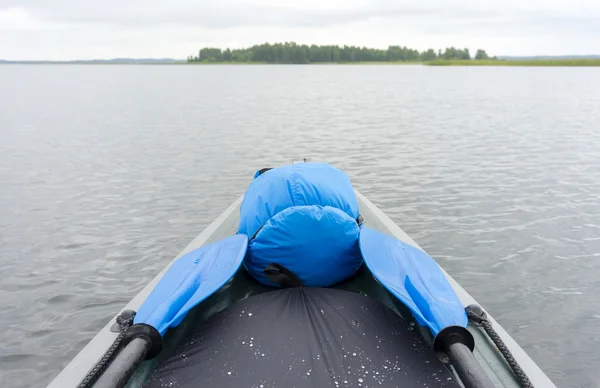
[0,59,600,67]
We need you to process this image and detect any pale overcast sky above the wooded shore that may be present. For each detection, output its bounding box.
[0,0,600,60]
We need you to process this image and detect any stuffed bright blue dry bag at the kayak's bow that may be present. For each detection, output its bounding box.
[238,163,362,287]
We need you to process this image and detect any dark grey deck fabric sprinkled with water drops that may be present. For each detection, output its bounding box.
[145,288,459,388]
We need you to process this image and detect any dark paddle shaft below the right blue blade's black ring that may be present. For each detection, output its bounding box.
[446,342,494,388]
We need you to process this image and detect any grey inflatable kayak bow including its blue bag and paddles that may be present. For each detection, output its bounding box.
[48,163,555,388]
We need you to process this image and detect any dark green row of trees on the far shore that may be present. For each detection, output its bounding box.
[188,42,495,64]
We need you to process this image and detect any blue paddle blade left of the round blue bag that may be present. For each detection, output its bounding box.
[134,234,248,335]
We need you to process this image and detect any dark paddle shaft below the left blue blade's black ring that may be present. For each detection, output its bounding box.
[94,338,150,388]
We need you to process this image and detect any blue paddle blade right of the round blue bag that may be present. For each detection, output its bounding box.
[359,227,468,337]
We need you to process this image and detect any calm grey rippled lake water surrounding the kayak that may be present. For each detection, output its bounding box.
[0,65,600,388]
